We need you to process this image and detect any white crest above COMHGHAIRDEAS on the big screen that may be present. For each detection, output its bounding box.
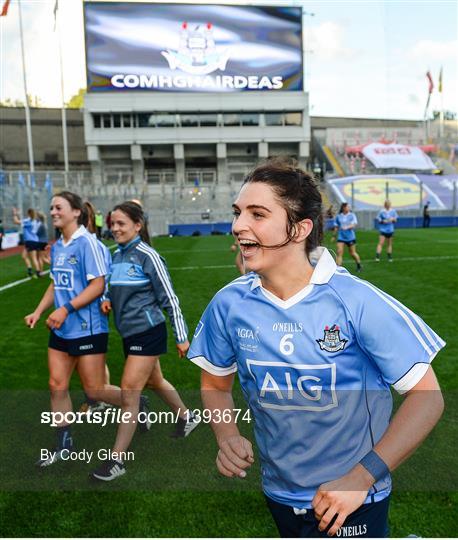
[161,22,229,75]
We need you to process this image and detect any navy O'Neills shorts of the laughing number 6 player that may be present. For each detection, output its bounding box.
[265,495,390,539]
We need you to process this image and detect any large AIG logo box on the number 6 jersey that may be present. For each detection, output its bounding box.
[246,359,338,411]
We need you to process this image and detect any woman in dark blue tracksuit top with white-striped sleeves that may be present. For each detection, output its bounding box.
[92,201,198,481]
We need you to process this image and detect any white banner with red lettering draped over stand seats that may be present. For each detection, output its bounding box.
[362,143,436,171]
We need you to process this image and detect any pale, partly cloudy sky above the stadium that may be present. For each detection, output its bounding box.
[0,0,458,120]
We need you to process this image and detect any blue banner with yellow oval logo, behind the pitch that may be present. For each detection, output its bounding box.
[329,174,458,211]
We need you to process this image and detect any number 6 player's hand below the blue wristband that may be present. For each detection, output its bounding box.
[312,464,374,536]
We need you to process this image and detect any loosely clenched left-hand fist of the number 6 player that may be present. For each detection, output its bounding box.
[216,435,254,478]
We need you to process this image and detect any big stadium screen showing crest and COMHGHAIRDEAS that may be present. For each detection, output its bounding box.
[84,2,303,92]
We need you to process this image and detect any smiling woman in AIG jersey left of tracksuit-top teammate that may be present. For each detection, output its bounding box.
[25,191,121,467]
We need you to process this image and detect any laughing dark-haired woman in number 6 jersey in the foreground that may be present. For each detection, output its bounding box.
[188,162,444,538]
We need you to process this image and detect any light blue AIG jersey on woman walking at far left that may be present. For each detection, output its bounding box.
[51,226,108,339]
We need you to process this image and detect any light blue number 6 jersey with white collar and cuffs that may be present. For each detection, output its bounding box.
[188,248,445,508]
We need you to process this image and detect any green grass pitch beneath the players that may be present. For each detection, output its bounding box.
[0,229,458,537]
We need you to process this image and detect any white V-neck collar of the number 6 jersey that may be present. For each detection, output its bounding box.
[251,247,337,309]
